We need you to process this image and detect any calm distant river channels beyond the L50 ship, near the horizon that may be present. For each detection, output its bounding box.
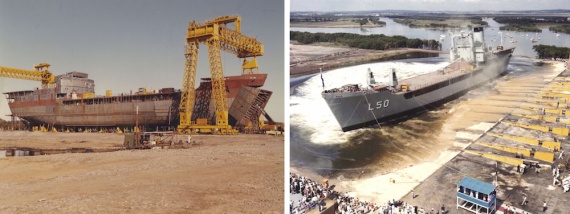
[291,18,570,58]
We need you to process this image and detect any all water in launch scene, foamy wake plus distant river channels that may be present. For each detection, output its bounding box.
[290,18,560,176]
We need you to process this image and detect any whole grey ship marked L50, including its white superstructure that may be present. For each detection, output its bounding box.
[322,26,514,132]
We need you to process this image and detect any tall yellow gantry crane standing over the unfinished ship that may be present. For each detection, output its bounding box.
[178,16,263,134]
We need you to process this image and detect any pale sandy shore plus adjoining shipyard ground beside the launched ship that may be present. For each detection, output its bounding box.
[291,59,570,213]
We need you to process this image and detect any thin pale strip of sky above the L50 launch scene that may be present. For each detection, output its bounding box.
[291,0,570,12]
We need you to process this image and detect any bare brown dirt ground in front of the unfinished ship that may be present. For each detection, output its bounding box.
[0,132,284,213]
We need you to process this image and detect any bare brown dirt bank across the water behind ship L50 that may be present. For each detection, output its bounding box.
[290,44,440,76]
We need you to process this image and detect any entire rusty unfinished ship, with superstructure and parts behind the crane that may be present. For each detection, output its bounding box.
[4,72,270,128]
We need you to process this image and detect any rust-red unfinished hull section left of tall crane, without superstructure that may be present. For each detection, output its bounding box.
[6,89,180,127]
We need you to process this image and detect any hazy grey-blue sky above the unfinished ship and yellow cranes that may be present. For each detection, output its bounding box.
[0,0,285,121]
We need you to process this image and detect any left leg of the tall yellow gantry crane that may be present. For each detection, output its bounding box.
[178,42,198,134]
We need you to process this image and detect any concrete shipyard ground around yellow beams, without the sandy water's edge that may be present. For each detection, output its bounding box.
[402,62,570,213]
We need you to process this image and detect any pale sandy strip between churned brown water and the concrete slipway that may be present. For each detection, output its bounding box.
[290,60,565,206]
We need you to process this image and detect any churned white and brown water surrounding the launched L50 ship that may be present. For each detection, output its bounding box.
[290,55,544,177]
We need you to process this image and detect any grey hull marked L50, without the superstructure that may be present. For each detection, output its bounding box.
[323,49,513,132]
